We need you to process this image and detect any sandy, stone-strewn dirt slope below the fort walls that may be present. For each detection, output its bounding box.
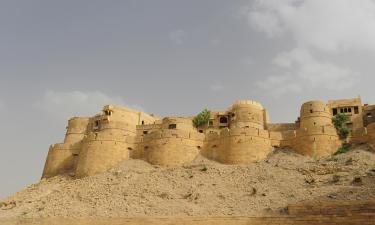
[0,145,375,219]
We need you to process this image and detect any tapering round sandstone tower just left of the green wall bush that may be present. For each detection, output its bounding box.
[293,101,341,157]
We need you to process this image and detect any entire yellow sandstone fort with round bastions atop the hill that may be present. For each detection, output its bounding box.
[43,97,375,178]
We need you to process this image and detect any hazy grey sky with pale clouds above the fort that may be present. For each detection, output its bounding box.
[0,0,375,198]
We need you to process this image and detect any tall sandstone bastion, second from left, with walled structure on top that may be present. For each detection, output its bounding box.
[76,106,157,177]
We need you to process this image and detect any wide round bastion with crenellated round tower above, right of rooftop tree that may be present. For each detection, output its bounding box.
[202,100,274,164]
